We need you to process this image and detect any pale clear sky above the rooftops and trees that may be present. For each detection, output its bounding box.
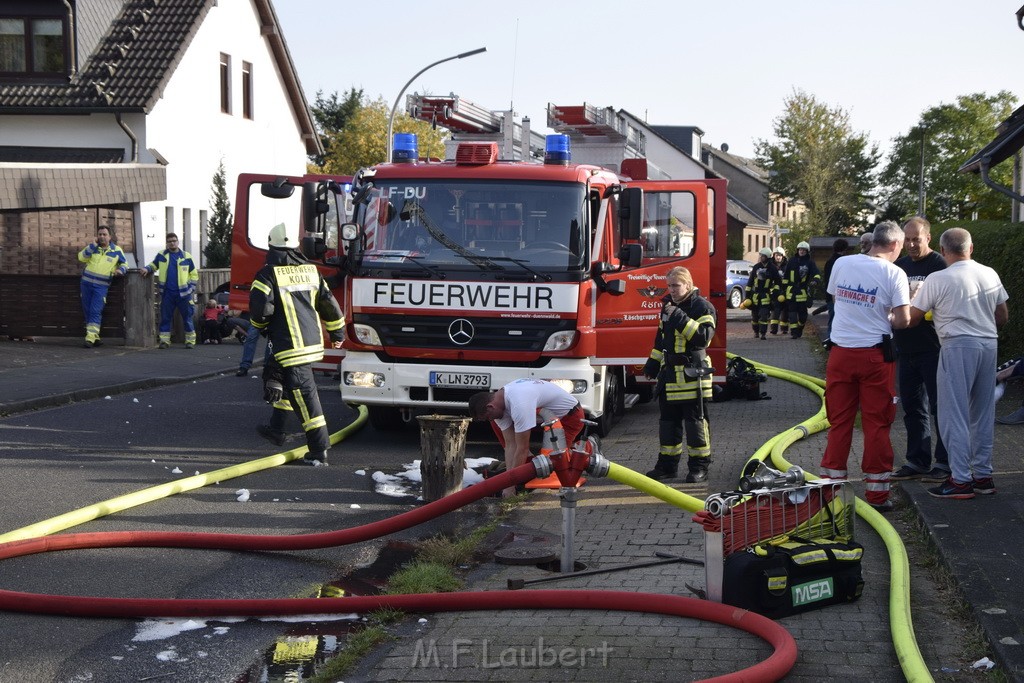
[274,0,1024,157]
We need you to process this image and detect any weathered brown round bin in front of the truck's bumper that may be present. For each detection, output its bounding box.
[416,415,471,503]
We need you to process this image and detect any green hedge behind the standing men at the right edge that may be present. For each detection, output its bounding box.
[932,220,1024,362]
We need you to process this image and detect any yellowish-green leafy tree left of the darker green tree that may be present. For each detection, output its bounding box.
[756,90,881,234]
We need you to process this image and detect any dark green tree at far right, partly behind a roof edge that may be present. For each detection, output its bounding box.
[881,90,1017,221]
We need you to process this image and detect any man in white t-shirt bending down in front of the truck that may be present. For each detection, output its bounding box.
[469,379,584,496]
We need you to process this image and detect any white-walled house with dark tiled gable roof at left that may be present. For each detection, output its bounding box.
[0,0,323,274]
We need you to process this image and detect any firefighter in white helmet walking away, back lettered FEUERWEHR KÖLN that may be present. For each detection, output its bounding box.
[249,224,345,465]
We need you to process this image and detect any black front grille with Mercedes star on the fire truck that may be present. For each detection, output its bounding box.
[352,313,573,353]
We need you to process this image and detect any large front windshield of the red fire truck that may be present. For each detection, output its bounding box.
[354,180,590,276]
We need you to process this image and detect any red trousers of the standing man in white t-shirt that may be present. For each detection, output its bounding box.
[821,346,896,504]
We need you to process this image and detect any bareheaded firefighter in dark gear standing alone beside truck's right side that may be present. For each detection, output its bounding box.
[643,266,717,483]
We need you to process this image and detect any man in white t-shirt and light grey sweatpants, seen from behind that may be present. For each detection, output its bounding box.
[910,227,1010,500]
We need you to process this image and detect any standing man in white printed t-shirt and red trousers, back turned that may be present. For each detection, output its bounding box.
[821,220,910,512]
